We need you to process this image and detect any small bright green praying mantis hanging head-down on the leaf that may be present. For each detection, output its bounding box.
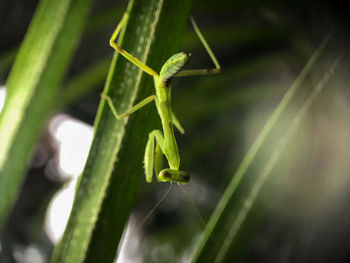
[101,13,220,184]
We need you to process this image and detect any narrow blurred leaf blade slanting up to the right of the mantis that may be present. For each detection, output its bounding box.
[191,35,328,262]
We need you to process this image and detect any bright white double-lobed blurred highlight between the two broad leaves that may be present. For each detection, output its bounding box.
[45,115,93,243]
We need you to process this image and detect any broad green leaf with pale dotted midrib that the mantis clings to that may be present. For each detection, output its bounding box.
[51,0,192,262]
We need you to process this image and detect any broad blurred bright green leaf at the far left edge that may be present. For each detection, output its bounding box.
[0,0,91,232]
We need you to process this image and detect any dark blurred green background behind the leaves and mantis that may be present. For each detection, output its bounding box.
[0,0,350,262]
